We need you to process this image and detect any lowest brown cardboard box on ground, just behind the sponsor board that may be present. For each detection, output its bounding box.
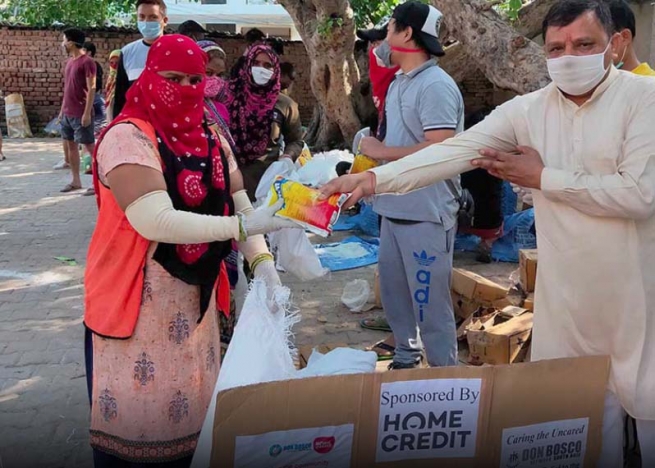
[466,312,532,365]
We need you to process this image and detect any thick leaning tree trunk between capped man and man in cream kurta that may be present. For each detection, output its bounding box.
[431,0,550,94]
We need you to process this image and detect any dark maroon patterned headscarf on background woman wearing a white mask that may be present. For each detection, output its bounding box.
[227,44,280,165]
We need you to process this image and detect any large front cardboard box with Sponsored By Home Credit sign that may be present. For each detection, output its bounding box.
[211,357,609,468]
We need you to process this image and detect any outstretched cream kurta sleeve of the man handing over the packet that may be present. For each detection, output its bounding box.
[372,103,517,194]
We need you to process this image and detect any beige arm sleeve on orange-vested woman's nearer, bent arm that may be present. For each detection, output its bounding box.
[125,190,239,244]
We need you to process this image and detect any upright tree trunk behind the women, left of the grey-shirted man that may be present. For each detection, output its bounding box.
[279,0,361,150]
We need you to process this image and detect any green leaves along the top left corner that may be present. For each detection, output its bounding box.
[0,0,144,27]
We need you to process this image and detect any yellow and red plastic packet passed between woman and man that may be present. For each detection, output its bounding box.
[269,177,350,237]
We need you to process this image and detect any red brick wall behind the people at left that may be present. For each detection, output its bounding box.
[0,27,315,132]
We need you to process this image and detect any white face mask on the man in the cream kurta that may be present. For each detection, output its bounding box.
[546,42,611,96]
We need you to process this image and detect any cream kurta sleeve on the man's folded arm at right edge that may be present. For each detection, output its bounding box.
[541,93,655,219]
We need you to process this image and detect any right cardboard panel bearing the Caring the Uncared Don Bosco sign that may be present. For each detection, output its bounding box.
[489,356,610,467]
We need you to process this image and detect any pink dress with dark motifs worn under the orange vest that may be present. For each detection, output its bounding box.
[91,125,221,463]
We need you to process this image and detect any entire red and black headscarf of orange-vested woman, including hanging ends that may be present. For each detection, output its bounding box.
[94,35,234,314]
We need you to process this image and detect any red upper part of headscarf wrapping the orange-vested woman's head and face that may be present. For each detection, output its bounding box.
[116,34,208,156]
